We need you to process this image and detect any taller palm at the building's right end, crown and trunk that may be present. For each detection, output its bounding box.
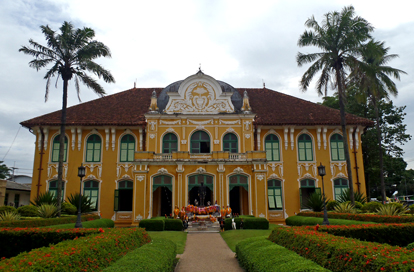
[296,6,373,204]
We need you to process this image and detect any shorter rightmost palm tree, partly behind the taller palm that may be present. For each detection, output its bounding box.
[350,40,406,202]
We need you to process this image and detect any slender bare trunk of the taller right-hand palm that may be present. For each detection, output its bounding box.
[335,67,355,206]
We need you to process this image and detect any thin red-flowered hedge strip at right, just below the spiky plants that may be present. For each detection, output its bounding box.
[297,212,414,223]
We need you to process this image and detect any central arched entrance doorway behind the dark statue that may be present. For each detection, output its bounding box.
[188,174,214,206]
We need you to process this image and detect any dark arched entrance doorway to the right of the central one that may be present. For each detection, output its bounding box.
[229,175,249,215]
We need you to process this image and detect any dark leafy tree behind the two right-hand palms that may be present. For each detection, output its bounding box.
[322,93,414,200]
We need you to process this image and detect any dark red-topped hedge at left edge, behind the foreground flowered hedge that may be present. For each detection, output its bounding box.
[0,228,98,258]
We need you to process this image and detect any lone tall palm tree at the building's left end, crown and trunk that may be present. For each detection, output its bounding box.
[19,22,115,216]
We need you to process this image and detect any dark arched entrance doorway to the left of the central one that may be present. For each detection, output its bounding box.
[152,175,172,217]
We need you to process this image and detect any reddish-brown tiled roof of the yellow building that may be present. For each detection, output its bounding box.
[20,88,372,128]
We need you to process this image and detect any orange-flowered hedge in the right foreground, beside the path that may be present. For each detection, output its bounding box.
[269,224,414,272]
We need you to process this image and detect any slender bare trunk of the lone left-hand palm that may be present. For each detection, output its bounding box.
[57,79,68,216]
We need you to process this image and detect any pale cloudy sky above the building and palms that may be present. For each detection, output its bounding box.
[0,0,414,176]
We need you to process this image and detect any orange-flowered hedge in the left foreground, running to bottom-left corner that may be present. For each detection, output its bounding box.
[0,228,150,272]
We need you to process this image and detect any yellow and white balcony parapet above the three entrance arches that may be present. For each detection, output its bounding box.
[135,151,266,162]
